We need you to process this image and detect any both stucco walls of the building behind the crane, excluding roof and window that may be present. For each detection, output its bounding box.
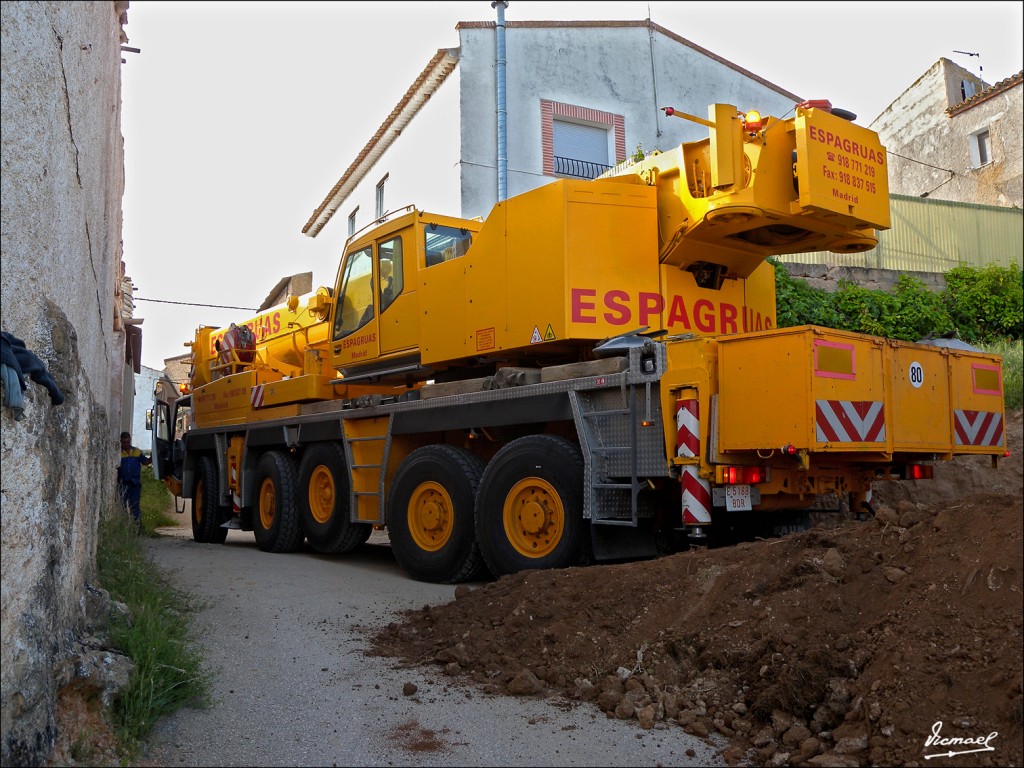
[319,23,802,230]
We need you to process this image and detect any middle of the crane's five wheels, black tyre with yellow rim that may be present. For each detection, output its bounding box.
[298,442,373,554]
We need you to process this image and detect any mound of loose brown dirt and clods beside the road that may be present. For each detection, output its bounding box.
[371,414,1024,766]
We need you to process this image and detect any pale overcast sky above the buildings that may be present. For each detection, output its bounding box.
[122,0,1024,370]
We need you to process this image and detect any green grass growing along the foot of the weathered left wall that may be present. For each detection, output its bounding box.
[96,468,212,754]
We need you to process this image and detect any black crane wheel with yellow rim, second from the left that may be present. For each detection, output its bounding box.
[253,451,302,552]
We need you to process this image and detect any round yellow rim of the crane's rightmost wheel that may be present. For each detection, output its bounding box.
[502,477,565,557]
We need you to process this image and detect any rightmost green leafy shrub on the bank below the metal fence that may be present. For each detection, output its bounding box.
[943,264,1024,343]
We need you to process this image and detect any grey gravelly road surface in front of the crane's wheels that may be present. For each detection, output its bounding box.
[144,520,725,766]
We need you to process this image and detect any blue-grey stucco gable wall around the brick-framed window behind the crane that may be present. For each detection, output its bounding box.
[456,26,798,216]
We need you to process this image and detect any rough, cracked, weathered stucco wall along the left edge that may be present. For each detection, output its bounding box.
[0,2,126,765]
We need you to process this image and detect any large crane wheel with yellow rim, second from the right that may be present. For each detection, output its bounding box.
[387,445,484,584]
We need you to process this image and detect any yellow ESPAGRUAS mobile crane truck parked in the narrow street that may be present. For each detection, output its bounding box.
[155,101,1005,583]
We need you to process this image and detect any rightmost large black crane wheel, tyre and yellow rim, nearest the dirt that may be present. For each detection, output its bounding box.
[476,435,589,577]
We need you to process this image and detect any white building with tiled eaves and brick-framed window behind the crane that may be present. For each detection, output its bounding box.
[303,17,806,237]
